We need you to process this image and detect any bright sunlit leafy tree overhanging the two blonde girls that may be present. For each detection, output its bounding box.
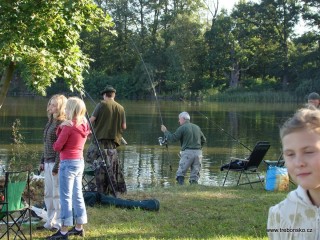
[0,0,112,109]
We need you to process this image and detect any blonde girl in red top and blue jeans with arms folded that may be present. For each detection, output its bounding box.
[47,97,90,239]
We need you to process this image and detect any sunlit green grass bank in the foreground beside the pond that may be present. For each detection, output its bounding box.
[33,184,287,240]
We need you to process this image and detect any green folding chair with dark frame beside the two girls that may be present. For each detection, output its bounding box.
[0,171,32,239]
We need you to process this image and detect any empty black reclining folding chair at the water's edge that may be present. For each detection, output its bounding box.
[221,141,270,188]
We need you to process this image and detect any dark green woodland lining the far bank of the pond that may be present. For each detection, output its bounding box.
[82,0,320,98]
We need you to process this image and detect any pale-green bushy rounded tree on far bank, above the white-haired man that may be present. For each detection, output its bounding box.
[165,15,205,94]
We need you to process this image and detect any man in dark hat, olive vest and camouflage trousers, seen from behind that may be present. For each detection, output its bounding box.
[87,85,127,194]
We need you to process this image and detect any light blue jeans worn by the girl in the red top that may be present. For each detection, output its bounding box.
[59,159,88,226]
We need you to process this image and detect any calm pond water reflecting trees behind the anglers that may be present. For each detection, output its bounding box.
[0,97,302,191]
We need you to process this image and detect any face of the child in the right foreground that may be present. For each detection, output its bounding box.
[282,130,320,190]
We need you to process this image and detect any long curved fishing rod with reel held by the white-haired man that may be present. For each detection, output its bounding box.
[132,41,172,171]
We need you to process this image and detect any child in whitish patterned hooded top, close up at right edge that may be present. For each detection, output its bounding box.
[267,108,320,240]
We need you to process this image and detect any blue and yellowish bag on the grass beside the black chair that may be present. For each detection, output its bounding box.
[265,165,289,191]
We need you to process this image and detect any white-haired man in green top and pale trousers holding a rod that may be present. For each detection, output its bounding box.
[161,112,206,185]
